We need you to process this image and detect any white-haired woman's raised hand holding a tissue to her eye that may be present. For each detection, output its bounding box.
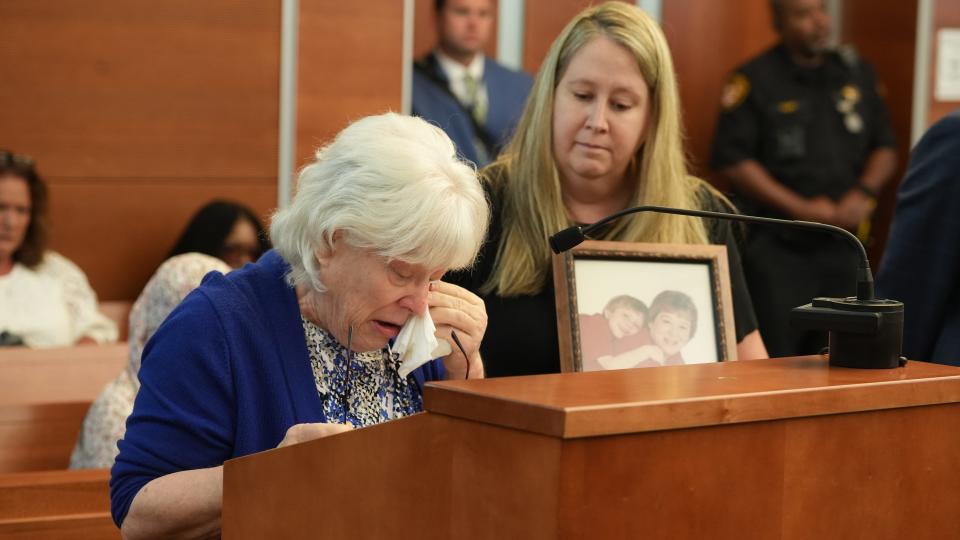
[427,281,487,379]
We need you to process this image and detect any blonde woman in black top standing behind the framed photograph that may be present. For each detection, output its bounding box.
[450,2,766,376]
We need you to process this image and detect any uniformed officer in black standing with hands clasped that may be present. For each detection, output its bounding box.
[711,0,896,356]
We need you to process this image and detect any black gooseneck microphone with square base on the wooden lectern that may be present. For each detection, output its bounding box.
[550,206,904,369]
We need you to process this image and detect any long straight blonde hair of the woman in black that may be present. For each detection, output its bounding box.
[482,2,709,296]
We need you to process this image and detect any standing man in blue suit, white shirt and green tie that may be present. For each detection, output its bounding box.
[413,0,532,167]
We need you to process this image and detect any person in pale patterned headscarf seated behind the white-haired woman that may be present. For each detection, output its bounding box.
[70,253,230,469]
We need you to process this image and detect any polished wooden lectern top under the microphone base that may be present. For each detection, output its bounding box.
[424,356,960,439]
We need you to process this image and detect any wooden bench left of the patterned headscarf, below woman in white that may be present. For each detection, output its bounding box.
[0,343,127,473]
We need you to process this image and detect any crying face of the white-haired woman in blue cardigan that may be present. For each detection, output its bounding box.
[317,237,446,351]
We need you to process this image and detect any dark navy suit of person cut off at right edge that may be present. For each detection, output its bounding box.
[877,111,960,365]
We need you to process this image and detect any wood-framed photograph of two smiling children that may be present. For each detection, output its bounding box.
[553,240,736,372]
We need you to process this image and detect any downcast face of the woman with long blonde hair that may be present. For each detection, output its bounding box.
[553,37,650,197]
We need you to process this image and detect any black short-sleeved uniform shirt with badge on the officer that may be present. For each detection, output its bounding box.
[711,45,894,217]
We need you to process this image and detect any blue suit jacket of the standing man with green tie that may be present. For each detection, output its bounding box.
[412,53,533,168]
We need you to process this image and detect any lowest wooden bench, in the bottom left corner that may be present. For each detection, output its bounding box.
[0,469,120,540]
